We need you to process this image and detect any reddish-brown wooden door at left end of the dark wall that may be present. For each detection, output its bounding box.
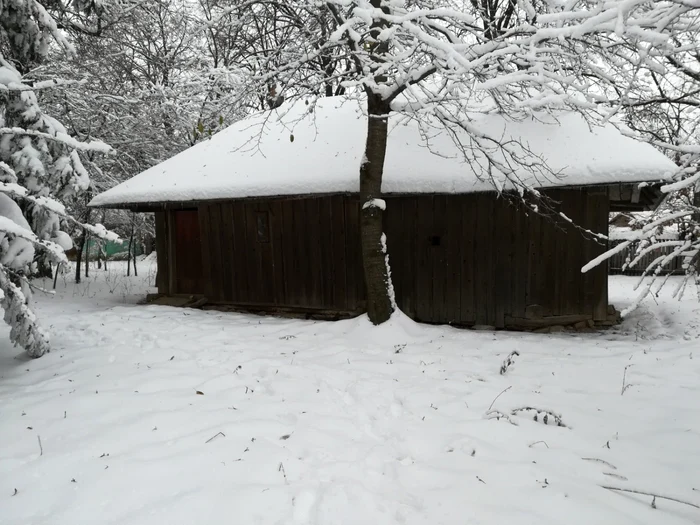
[173,210,204,294]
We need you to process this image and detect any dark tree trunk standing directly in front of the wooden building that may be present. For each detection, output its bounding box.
[360,93,393,325]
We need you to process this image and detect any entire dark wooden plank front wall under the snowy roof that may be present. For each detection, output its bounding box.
[156,188,609,327]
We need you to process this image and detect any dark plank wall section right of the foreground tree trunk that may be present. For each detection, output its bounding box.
[385,188,608,327]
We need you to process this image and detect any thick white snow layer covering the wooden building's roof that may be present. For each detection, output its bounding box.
[91,98,675,206]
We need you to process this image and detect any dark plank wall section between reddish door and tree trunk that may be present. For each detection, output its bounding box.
[194,195,365,312]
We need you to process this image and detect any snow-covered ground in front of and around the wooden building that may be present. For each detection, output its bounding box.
[0,262,700,525]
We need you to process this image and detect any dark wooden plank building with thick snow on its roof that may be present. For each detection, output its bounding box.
[91,99,673,328]
